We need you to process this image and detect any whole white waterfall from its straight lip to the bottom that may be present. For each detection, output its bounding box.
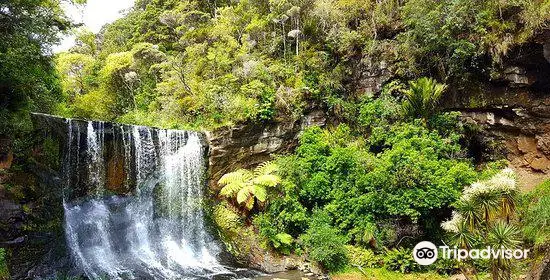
[64,120,235,279]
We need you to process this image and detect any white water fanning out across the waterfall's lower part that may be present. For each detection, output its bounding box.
[65,196,252,279]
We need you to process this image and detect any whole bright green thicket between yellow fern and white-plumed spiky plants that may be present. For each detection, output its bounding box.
[240,83,479,272]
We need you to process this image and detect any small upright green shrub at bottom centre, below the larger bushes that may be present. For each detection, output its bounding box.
[301,211,348,271]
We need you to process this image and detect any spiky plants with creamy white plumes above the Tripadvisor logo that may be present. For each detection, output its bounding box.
[442,169,521,280]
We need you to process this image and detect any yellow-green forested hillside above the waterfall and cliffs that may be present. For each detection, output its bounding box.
[52,0,550,127]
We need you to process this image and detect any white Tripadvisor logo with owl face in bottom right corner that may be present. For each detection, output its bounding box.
[413,241,529,265]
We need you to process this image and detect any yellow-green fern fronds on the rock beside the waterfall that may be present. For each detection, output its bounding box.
[218,162,281,210]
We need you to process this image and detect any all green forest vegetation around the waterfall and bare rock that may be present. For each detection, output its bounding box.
[0,0,550,280]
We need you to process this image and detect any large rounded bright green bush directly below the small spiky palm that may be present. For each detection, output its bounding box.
[357,122,476,221]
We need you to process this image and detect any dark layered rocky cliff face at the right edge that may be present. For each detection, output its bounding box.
[445,37,550,188]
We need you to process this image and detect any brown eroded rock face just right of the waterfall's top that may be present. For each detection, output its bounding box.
[206,109,326,190]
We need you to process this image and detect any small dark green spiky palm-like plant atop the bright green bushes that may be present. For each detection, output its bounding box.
[403,77,447,120]
